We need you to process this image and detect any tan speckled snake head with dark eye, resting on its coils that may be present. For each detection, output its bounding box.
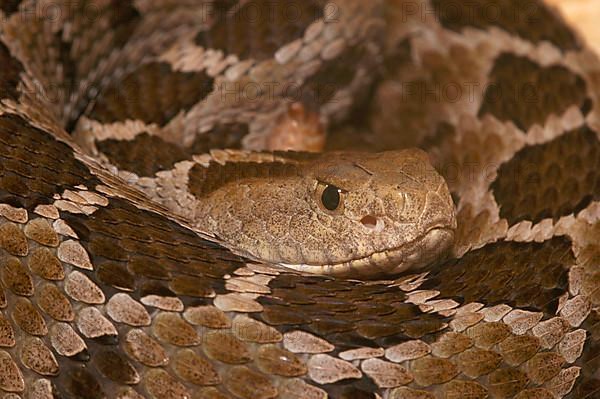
[190,149,456,278]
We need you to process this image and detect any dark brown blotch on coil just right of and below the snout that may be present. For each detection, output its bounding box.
[421,237,575,314]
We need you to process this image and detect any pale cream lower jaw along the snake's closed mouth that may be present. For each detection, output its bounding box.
[281,226,454,278]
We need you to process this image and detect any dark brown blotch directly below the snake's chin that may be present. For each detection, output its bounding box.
[255,274,438,350]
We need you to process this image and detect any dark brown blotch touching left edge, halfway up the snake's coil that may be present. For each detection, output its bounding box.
[0,115,98,210]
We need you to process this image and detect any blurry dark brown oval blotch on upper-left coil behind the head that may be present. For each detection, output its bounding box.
[87,62,214,126]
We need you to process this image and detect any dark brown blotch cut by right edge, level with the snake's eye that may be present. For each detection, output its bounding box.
[491,127,600,225]
